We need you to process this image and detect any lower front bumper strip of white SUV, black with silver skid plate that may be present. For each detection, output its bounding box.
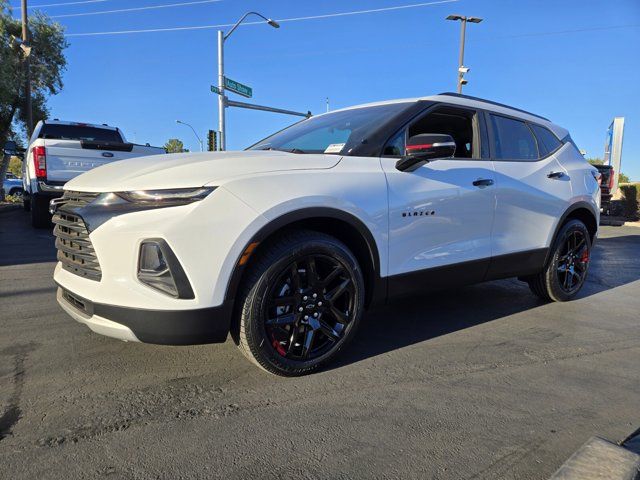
[57,287,233,345]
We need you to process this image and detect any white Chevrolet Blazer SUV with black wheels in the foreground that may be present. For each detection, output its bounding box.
[53,93,600,375]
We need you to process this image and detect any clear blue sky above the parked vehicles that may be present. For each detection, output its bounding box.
[14,0,640,180]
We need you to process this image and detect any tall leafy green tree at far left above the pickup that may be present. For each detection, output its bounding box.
[0,0,68,145]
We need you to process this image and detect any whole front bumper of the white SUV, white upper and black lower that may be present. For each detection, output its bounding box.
[54,188,266,345]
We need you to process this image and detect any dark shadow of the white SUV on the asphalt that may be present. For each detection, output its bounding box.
[327,235,640,370]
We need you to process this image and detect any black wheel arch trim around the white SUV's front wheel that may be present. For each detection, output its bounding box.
[225,207,386,307]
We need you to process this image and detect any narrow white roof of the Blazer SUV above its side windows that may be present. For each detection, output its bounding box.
[333,92,569,139]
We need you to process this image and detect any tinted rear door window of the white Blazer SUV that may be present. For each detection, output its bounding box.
[491,115,538,160]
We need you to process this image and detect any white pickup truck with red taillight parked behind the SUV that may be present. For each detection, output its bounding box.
[22,120,166,228]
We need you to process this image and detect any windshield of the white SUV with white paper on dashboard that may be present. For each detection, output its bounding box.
[249,103,410,154]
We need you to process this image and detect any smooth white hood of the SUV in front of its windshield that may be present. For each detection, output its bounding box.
[64,150,341,192]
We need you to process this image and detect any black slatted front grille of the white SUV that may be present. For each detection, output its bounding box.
[53,191,102,281]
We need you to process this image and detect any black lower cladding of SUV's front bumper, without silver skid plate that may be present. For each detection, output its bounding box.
[60,287,233,345]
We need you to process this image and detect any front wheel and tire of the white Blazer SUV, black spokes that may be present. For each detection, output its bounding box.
[238,231,364,376]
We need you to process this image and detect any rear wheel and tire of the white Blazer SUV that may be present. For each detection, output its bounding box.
[527,219,591,302]
